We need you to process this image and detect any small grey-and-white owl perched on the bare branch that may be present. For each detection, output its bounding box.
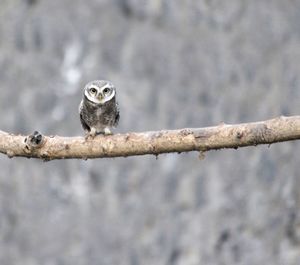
[79,80,120,138]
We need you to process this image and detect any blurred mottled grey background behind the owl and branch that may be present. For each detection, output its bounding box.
[0,0,300,265]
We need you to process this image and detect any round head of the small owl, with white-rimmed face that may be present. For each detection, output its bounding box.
[84,80,116,104]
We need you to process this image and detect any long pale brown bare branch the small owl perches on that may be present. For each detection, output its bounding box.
[0,116,300,161]
